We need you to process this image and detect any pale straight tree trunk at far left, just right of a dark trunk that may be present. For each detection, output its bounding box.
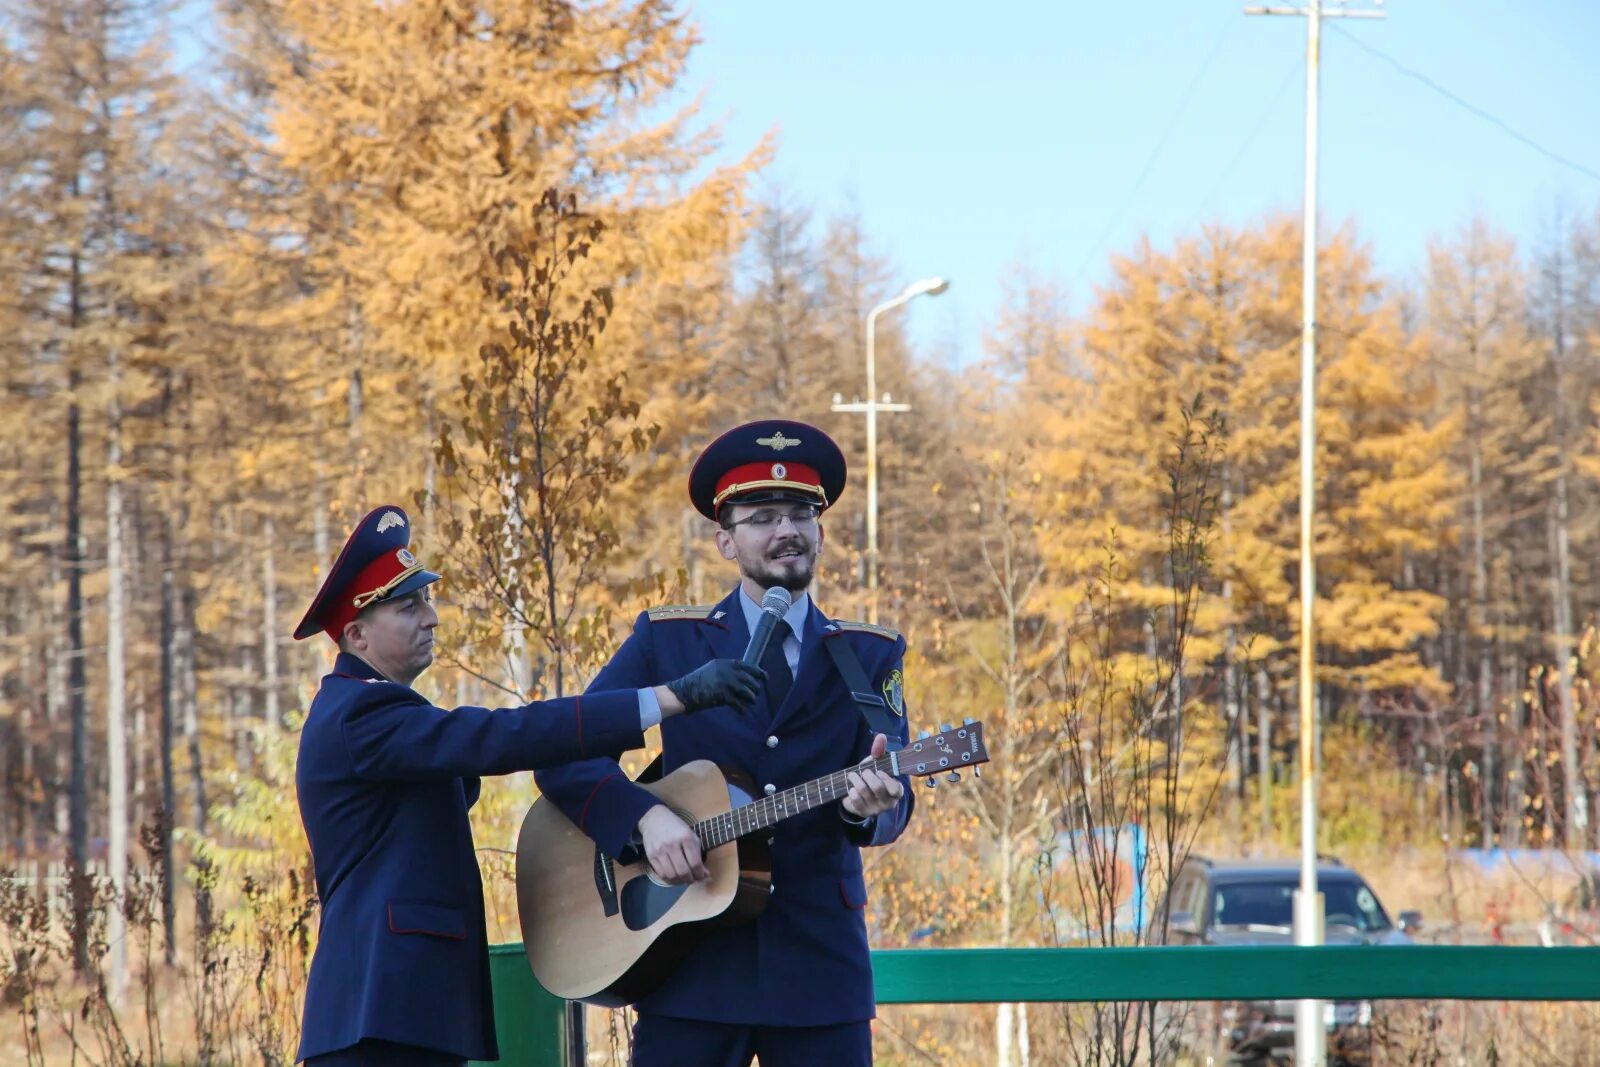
[106,352,128,1001]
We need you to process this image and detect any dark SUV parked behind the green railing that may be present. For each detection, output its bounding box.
[1155,856,1422,1064]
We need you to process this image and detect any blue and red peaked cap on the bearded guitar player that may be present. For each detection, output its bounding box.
[690,419,845,522]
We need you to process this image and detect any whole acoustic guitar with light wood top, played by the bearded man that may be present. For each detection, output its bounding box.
[517,720,989,1008]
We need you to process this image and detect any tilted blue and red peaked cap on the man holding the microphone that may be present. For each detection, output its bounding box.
[294,506,438,641]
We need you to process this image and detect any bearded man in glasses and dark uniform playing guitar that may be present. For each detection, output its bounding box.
[538,421,912,1067]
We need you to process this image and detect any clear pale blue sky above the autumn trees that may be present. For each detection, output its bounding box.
[685,0,1600,362]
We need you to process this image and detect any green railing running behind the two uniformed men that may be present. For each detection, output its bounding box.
[490,944,1600,1067]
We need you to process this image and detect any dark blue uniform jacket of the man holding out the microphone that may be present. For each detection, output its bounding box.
[294,654,643,1059]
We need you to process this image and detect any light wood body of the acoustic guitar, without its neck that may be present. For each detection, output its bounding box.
[517,760,771,1008]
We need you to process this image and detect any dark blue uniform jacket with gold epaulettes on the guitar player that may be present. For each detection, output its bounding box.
[536,587,912,1027]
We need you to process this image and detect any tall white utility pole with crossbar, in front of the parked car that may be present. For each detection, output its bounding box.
[1245,0,1384,1067]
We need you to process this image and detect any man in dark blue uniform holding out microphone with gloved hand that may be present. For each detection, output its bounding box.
[294,507,765,1067]
